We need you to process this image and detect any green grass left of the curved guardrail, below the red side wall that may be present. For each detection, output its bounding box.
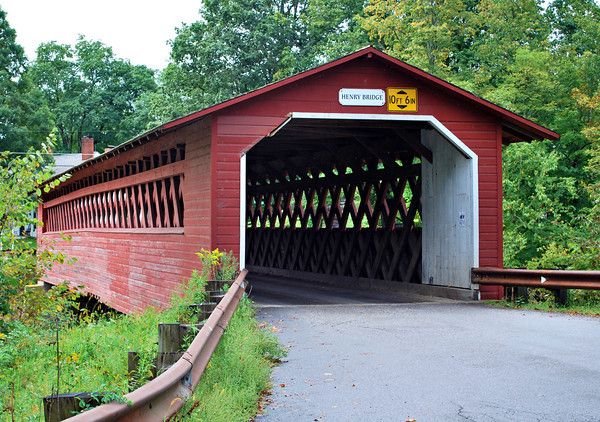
[0,310,160,421]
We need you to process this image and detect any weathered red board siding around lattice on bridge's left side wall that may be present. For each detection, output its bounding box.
[40,119,211,312]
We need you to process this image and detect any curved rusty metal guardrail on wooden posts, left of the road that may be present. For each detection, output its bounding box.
[66,270,248,422]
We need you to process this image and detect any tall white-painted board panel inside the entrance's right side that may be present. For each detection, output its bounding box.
[421,129,477,288]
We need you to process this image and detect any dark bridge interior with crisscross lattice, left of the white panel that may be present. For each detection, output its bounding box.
[246,119,433,285]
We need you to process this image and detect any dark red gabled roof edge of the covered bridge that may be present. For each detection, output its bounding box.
[45,46,560,184]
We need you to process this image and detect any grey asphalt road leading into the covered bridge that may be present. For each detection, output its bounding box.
[253,280,600,422]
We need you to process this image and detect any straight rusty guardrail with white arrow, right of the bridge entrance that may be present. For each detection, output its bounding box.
[471,267,600,290]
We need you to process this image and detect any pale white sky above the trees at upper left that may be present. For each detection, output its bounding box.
[0,0,200,69]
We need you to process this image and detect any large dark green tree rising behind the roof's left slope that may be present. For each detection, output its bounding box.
[140,0,368,123]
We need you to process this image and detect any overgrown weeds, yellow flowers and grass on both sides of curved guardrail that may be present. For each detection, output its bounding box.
[0,250,282,421]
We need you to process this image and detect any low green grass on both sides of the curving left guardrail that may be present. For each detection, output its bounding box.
[0,277,284,422]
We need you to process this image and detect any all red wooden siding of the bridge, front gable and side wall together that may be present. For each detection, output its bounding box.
[40,56,510,312]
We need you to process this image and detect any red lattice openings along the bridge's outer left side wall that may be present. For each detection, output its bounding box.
[43,144,185,232]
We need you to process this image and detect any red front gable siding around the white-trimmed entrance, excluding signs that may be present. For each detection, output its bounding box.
[212,58,502,298]
